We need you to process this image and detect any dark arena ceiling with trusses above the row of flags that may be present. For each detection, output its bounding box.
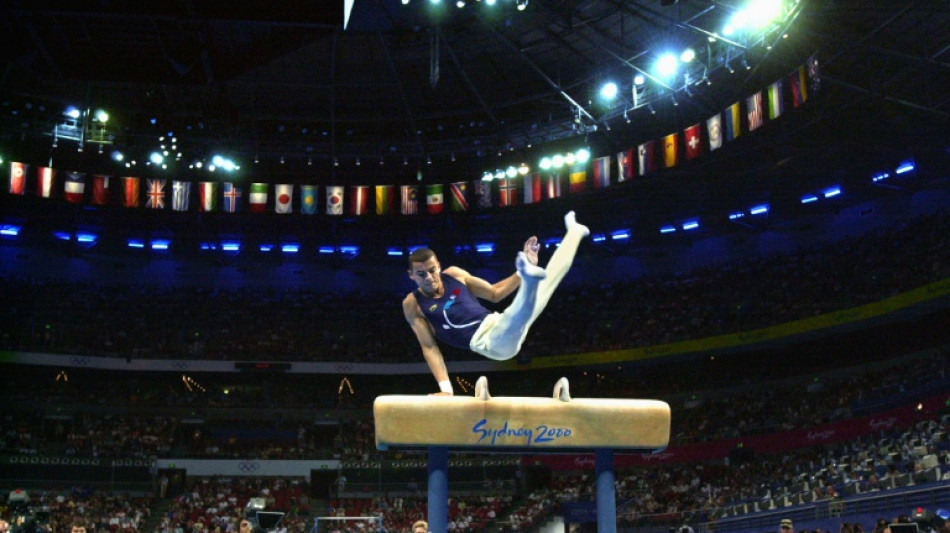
[0,0,950,234]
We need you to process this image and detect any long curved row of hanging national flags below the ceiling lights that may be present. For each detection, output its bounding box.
[9,56,820,216]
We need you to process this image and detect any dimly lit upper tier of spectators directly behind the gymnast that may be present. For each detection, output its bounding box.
[0,213,950,362]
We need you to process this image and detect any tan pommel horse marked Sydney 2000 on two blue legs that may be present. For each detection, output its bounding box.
[373,376,670,533]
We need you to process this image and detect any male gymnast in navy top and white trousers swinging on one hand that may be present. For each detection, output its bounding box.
[402,211,590,396]
